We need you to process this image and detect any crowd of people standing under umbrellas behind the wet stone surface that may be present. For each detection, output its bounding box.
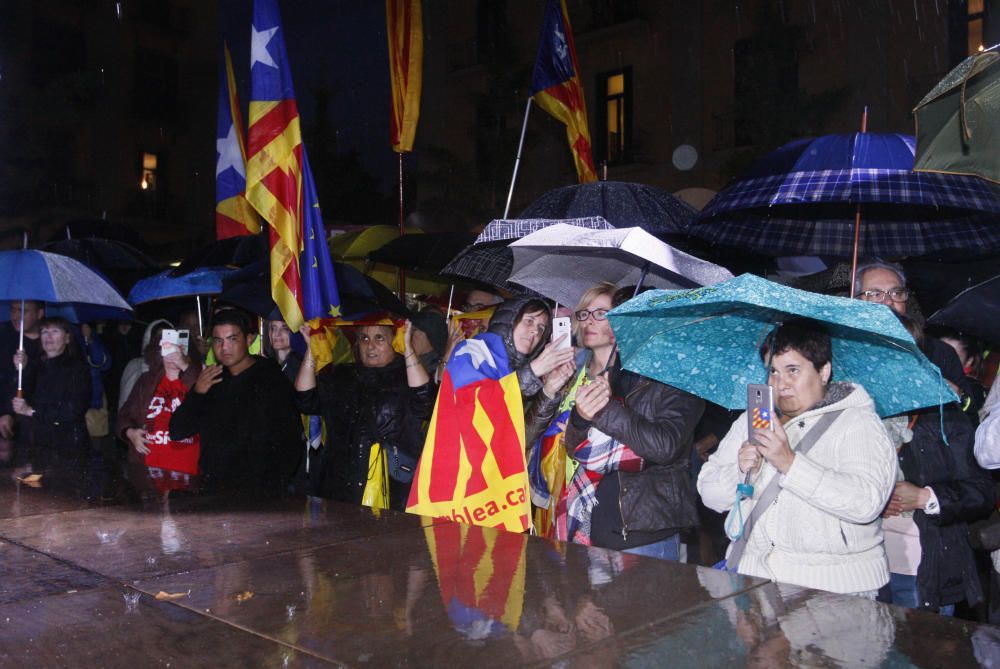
[0,261,1000,622]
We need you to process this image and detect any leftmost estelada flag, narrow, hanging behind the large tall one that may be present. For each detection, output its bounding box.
[215,44,260,239]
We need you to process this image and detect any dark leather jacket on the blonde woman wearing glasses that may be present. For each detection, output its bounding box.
[565,354,705,545]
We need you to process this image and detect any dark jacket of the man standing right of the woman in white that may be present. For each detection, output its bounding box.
[899,404,995,609]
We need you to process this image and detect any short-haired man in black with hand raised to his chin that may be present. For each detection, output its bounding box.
[170,309,303,495]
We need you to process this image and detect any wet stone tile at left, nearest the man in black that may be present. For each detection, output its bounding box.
[0,499,442,582]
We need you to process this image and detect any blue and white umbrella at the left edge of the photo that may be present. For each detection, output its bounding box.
[0,249,132,311]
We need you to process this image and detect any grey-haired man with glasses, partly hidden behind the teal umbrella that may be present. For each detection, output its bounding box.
[854,260,994,615]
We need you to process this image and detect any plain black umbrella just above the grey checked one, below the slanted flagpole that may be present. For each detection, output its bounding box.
[518,181,698,237]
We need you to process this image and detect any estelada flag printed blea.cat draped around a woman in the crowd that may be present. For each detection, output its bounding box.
[406,333,531,532]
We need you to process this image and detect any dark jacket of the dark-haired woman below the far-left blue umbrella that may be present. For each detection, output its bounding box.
[24,353,91,455]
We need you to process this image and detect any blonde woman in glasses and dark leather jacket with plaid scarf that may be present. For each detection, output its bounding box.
[537,282,705,560]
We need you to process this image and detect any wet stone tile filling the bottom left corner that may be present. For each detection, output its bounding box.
[0,586,331,669]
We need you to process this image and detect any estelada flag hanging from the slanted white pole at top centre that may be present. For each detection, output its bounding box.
[531,0,597,183]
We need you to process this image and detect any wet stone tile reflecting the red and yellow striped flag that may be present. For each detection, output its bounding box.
[135,523,763,669]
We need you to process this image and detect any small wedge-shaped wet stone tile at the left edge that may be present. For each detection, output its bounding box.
[0,541,109,606]
